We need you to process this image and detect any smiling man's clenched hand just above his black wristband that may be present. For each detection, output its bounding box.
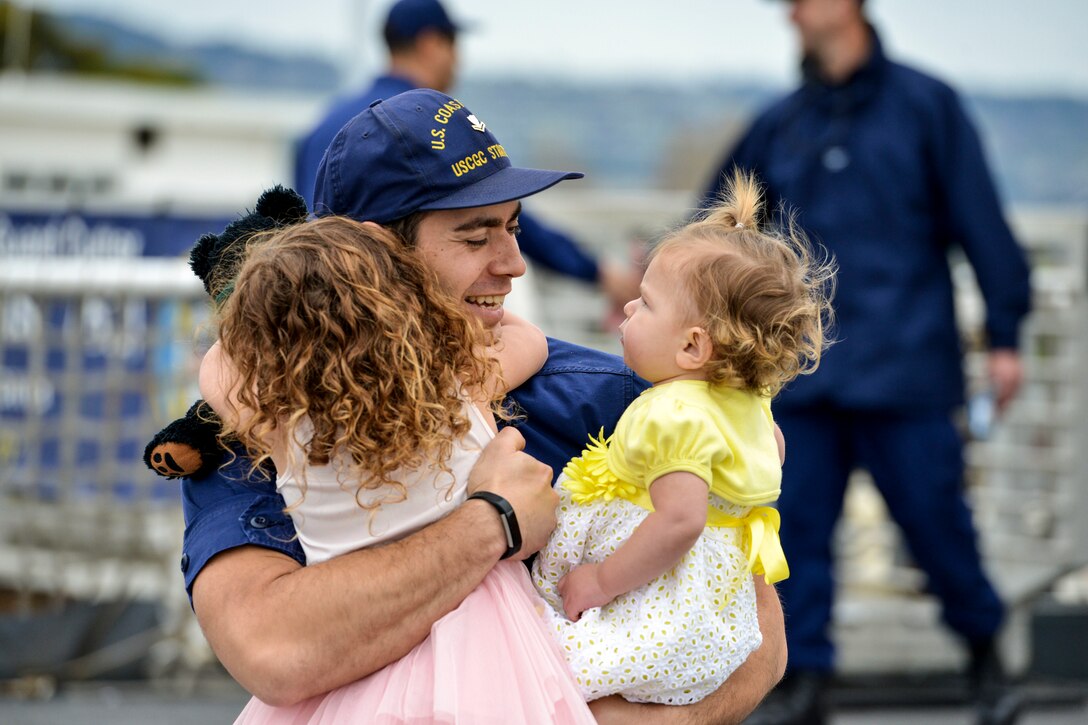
[468,428,559,560]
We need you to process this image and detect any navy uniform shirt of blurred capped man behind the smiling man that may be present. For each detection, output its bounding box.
[295,75,599,282]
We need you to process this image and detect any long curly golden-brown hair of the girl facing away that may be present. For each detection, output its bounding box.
[211,217,498,508]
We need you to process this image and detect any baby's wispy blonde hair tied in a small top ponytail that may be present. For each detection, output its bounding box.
[653,170,834,395]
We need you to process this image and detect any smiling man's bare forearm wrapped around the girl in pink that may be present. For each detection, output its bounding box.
[193,501,505,704]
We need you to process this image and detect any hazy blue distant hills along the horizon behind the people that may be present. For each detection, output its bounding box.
[34,9,1088,205]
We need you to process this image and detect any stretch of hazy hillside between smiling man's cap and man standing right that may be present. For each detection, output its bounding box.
[455,77,775,189]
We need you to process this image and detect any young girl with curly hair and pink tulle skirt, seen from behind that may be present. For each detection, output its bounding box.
[200,217,593,723]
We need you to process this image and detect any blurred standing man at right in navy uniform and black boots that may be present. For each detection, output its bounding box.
[703,0,1030,724]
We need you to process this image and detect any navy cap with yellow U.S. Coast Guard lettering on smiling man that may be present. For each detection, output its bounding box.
[313,88,583,224]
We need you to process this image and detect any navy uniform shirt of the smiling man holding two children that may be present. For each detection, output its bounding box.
[182,339,647,597]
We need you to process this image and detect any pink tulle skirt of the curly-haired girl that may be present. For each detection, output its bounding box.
[235,561,595,725]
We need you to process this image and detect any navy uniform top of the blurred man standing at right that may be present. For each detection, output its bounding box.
[703,33,1029,409]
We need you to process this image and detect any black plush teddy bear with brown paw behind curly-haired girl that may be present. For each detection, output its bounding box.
[144,186,307,479]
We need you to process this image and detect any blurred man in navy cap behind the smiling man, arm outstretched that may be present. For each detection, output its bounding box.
[295,0,641,309]
